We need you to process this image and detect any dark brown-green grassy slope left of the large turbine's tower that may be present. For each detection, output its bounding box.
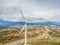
[0,30,24,44]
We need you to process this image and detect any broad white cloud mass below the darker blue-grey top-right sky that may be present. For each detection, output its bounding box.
[0,0,60,22]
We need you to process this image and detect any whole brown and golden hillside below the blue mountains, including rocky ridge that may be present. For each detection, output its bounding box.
[0,26,60,45]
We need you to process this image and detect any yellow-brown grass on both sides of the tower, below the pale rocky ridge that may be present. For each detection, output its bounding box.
[0,27,60,45]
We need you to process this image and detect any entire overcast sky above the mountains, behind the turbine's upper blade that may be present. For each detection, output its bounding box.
[0,0,60,22]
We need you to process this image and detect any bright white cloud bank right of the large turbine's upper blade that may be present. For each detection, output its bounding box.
[33,9,60,22]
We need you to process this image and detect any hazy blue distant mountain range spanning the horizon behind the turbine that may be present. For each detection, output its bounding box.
[0,21,60,27]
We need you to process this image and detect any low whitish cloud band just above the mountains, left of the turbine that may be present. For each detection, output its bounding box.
[0,15,24,22]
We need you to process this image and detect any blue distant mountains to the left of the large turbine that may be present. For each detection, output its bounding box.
[0,21,24,28]
